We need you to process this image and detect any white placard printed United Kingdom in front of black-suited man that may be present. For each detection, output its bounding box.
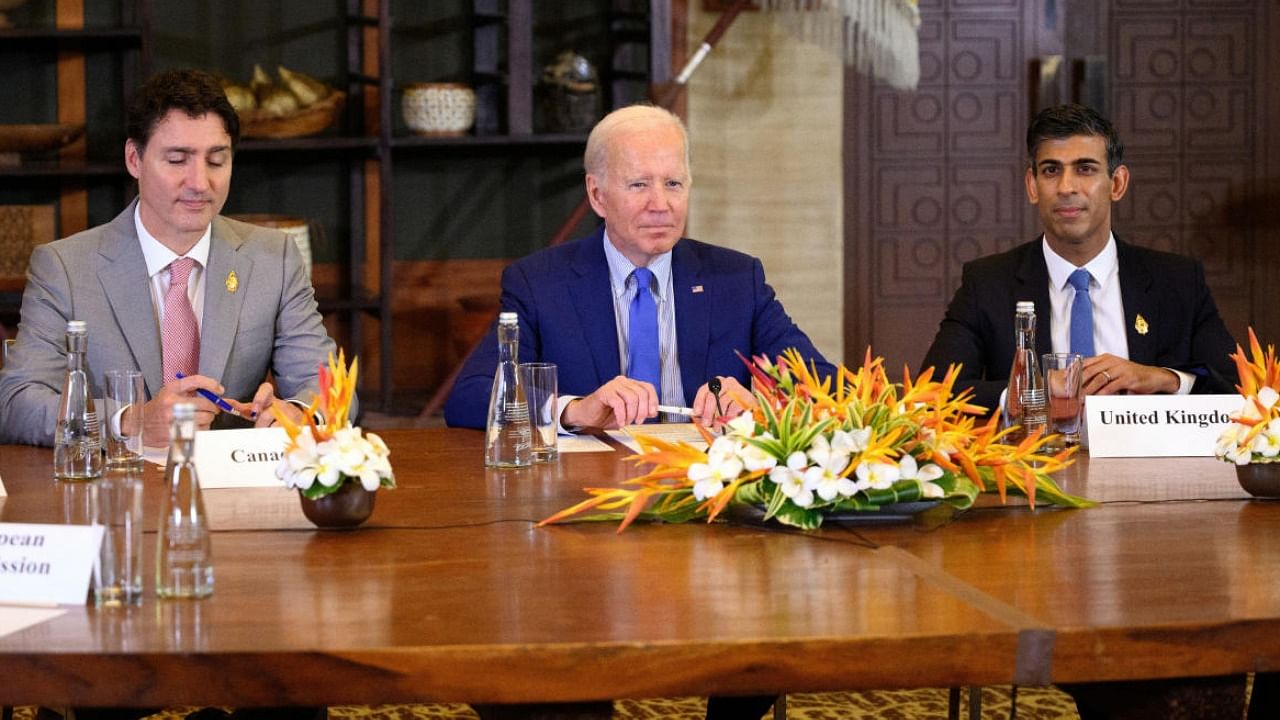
[1084,395,1244,457]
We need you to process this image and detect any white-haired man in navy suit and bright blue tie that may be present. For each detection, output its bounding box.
[444,105,833,428]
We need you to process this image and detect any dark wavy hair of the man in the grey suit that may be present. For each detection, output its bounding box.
[124,69,239,152]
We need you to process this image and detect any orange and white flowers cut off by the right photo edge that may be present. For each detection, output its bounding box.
[1215,328,1280,466]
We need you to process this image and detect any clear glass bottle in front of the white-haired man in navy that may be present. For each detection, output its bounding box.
[484,313,534,468]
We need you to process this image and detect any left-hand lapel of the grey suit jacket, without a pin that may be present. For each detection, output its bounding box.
[97,201,164,397]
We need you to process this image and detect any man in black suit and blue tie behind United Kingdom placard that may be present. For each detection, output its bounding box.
[924,105,1235,409]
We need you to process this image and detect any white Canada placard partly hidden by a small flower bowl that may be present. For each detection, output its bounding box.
[195,428,289,488]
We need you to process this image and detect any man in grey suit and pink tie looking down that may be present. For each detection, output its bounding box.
[0,70,334,446]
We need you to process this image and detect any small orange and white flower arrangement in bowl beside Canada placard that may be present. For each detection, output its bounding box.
[271,351,396,525]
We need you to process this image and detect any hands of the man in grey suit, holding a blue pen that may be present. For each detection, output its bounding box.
[138,375,302,447]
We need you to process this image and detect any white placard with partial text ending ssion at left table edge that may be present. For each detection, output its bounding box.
[0,523,102,605]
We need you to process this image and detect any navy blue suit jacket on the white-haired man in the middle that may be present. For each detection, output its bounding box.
[444,228,835,428]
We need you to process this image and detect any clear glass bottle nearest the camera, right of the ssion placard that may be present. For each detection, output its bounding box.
[156,402,214,597]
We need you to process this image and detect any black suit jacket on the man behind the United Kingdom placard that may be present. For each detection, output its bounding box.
[923,240,1236,409]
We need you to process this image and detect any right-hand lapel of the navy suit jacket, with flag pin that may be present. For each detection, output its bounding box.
[671,240,721,402]
